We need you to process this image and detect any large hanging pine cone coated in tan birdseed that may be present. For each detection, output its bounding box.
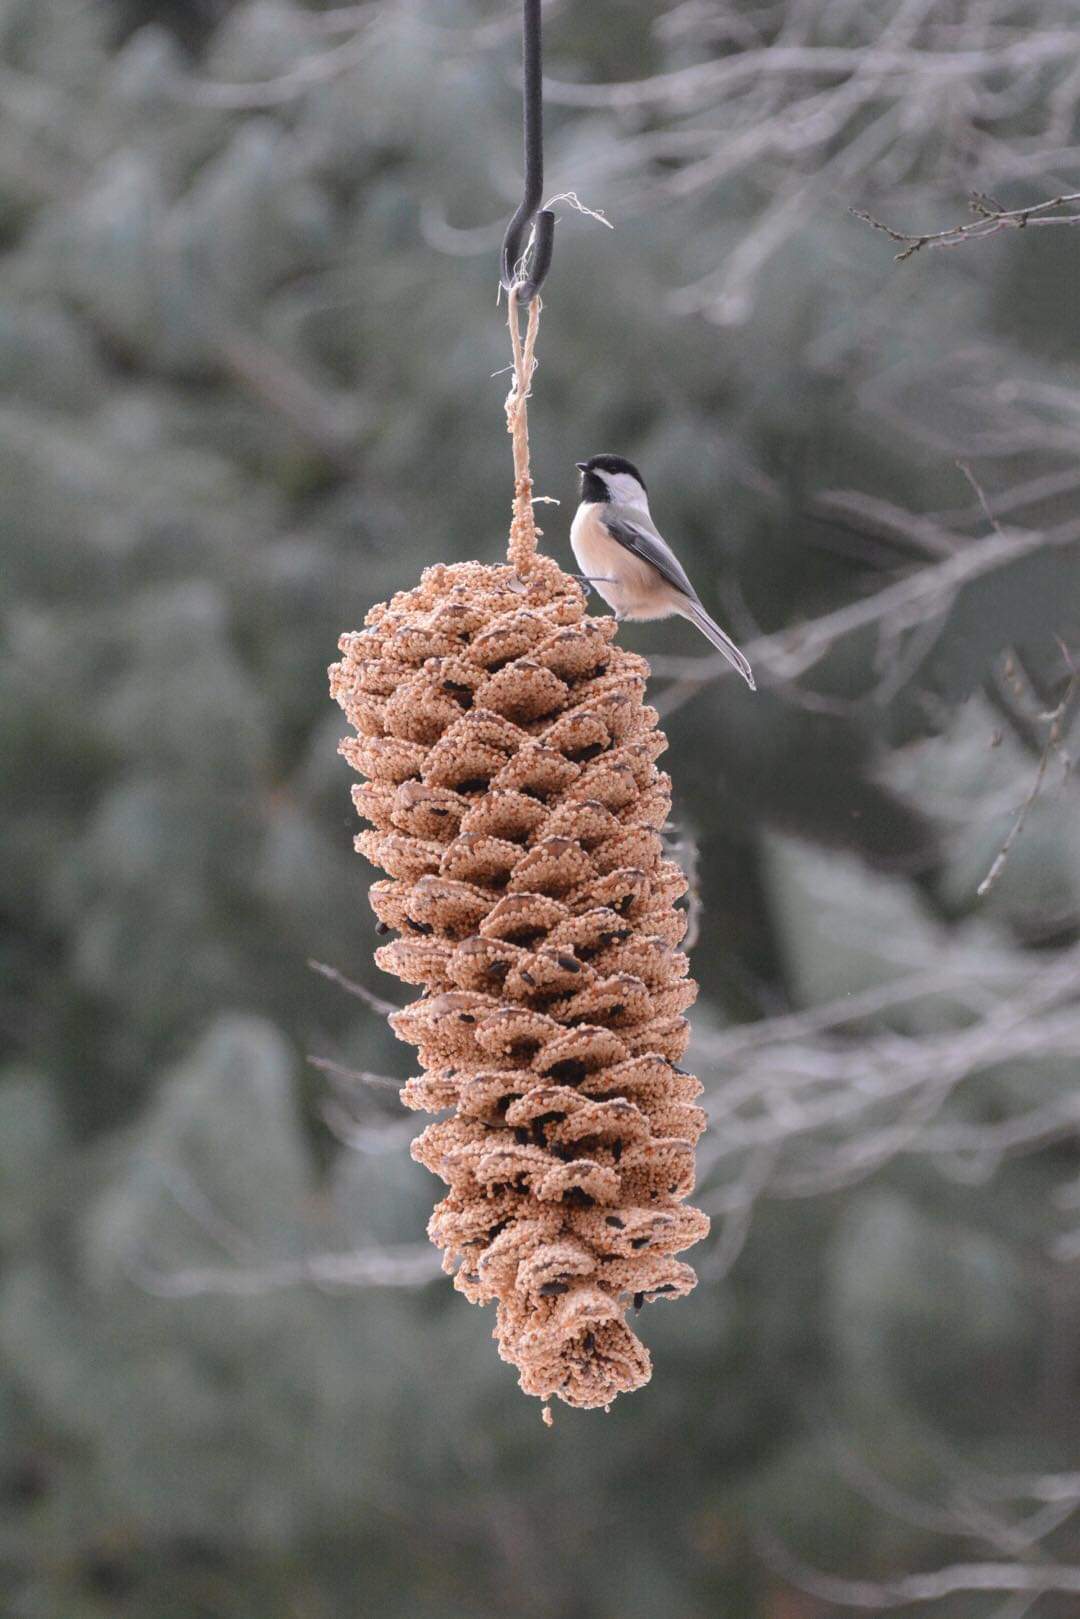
[330,557,709,1405]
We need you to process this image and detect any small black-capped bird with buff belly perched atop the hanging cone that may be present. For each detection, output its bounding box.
[570,455,758,691]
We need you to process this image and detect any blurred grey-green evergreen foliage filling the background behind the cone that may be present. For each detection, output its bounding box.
[0,0,1080,1619]
